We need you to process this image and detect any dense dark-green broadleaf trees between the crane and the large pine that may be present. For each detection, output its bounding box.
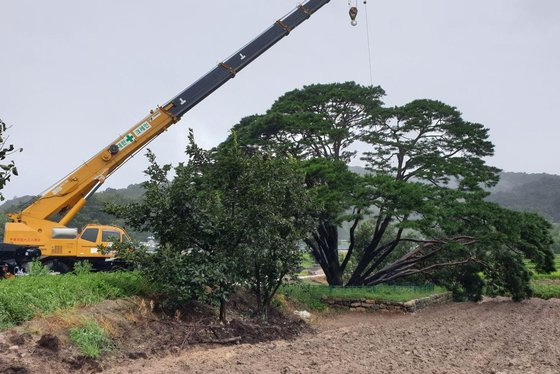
[110,133,316,316]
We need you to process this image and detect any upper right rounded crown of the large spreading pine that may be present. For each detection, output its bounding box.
[363,100,499,190]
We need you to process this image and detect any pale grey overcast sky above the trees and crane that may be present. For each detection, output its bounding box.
[0,0,560,198]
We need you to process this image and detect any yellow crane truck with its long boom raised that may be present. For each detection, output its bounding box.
[0,0,329,277]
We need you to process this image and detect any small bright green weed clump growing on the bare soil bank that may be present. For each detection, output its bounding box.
[68,321,111,358]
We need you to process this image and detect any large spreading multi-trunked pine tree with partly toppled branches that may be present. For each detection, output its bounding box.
[222,82,554,300]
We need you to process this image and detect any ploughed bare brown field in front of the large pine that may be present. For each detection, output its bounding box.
[106,299,560,373]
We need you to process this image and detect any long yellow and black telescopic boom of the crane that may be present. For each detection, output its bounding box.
[11,0,330,225]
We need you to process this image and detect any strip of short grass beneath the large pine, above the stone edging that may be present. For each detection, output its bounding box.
[278,283,445,311]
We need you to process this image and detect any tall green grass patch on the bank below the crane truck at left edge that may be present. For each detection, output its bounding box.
[0,272,148,330]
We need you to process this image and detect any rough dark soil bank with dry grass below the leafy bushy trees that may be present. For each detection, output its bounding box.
[0,297,308,373]
